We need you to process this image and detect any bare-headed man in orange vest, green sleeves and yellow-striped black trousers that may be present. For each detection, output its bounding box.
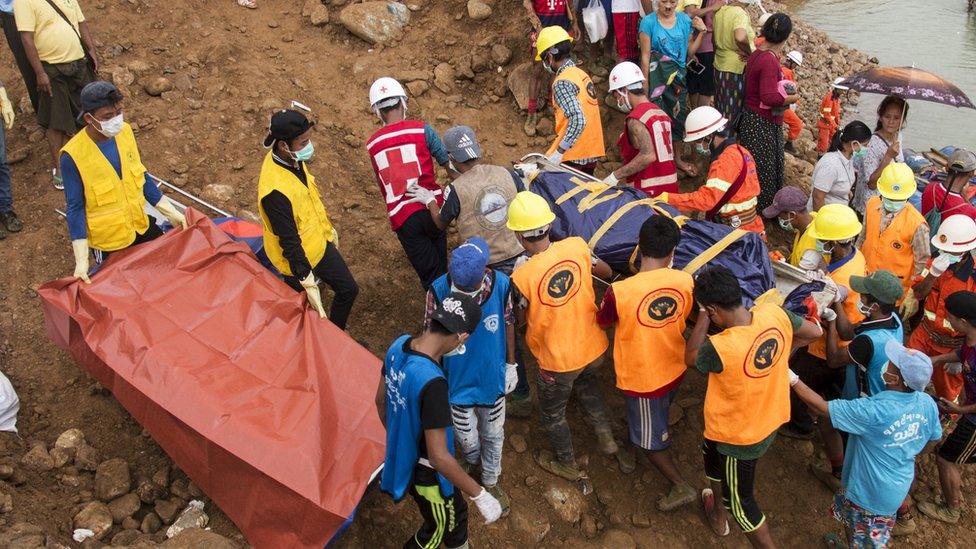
[685,266,823,547]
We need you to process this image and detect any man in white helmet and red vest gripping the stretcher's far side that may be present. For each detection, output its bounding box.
[603,61,678,197]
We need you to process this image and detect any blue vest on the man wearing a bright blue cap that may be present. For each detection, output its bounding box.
[431,271,510,406]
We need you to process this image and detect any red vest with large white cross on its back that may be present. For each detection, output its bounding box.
[366,120,444,231]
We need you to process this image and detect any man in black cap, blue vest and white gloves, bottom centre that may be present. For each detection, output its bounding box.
[376,293,502,549]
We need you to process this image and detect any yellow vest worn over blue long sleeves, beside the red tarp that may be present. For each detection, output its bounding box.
[61,124,149,252]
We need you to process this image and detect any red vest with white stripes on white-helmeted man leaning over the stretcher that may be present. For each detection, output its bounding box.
[617,101,678,197]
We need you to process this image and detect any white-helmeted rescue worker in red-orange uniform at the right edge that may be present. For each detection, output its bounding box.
[908,214,976,402]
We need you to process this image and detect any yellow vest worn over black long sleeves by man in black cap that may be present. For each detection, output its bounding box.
[258,152,332,276]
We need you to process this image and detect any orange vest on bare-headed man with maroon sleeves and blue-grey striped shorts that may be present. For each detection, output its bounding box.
[611,269,695,393]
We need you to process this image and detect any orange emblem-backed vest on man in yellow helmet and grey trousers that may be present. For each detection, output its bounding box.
[512,236,609,372]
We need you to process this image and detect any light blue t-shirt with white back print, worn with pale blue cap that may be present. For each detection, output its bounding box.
[827,391,942,515]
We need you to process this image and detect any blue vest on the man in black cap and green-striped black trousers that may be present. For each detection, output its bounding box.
[380,335,454,501]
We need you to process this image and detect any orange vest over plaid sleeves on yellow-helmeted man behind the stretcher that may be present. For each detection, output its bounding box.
[546,67,606,162]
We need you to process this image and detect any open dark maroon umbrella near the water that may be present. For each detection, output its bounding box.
[839,67,976,109]
